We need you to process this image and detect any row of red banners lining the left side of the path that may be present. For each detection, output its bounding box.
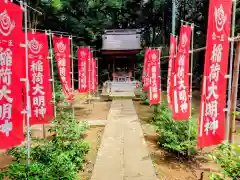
[0,0,97,149]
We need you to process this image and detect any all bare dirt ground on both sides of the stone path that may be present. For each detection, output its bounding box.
[0,95,232,180]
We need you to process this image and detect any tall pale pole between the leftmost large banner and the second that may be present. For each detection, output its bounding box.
[24,2,31,166]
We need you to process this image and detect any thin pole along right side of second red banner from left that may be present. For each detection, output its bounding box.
[49,30,57,119]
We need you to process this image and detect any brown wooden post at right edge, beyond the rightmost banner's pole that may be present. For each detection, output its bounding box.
[229,38,240,143]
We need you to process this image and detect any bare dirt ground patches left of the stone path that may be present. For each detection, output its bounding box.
[0,100,111,180]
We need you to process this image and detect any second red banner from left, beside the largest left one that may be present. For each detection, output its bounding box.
[28,32,53,124]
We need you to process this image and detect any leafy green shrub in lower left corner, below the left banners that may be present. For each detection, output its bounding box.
[0,109,89,180]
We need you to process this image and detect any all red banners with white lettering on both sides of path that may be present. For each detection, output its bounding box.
[0,0,232,149]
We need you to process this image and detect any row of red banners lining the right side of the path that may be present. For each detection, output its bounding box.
[142,0,232,148]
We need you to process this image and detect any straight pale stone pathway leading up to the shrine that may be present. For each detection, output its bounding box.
[91,100,157,180]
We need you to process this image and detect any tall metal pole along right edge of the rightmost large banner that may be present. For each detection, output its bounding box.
[226,0,236,141]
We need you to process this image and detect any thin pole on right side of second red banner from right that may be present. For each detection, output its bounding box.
[188,23,194,156]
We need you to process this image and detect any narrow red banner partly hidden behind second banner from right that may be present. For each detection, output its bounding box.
[167,35,177,108]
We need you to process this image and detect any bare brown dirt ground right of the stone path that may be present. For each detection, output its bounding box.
[135,101,216,180]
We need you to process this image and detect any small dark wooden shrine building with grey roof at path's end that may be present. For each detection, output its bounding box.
[101,29,141,82]
